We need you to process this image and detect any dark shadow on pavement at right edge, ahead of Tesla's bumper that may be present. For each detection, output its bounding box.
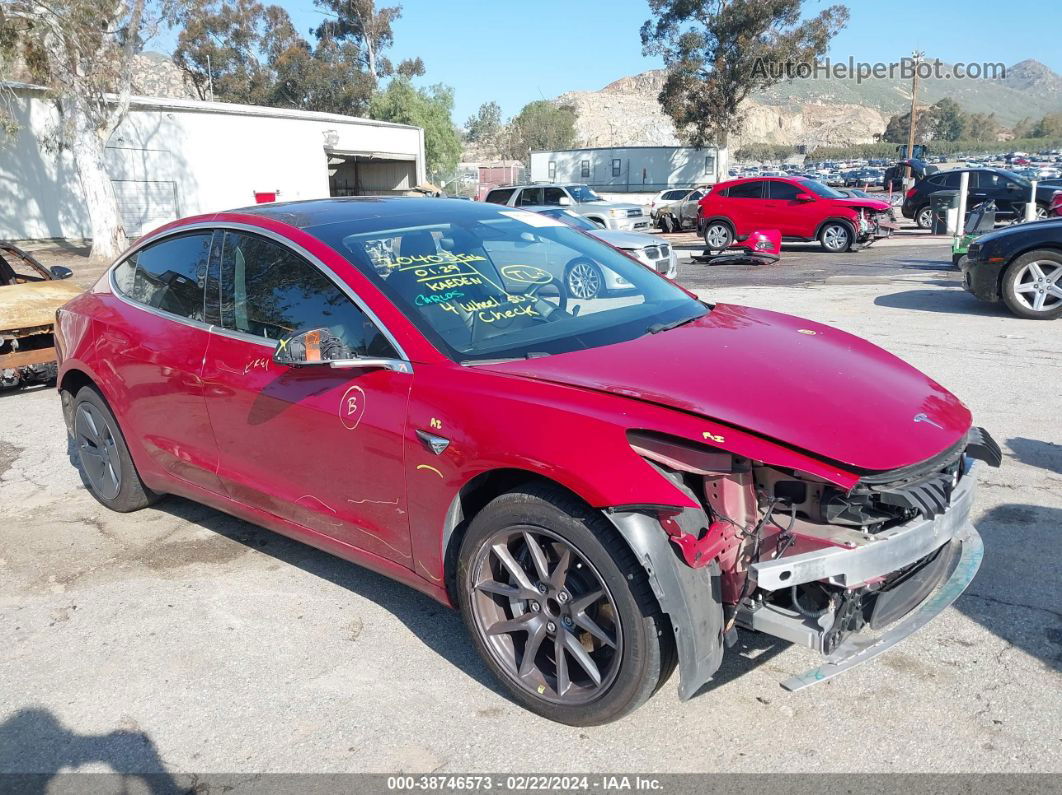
[955,503,1062,671]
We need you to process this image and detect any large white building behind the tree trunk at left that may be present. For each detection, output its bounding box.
[0,85,425,240]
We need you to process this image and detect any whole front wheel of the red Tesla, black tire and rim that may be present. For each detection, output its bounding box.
[457,484,673,726]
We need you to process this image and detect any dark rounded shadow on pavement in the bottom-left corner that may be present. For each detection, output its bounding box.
[0,707,181,795]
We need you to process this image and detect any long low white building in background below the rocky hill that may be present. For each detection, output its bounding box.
[531,146,726,193]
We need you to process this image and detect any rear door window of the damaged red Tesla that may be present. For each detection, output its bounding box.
[115,231,212,322]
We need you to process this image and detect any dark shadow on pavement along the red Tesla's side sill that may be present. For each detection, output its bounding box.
[148,496,508,697]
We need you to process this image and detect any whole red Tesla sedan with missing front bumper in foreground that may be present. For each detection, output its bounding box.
[56,197,999,725]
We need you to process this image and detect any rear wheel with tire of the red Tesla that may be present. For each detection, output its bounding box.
[70,386,160,514]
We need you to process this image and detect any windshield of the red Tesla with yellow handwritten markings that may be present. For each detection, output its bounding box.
[307,200,708,363]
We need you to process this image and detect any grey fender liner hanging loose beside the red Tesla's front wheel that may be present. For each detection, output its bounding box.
[605,508,723,699]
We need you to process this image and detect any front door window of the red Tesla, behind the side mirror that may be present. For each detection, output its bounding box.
[221,231,396,358]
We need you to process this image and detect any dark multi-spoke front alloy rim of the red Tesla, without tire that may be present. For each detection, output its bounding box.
[468,525,623,705]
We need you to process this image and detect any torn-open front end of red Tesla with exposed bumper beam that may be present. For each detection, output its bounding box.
[610,428,1001,698]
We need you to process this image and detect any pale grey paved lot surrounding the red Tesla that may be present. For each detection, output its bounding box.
[0,238,1062,773]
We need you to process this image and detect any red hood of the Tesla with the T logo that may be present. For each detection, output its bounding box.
[483,304,971,471]
